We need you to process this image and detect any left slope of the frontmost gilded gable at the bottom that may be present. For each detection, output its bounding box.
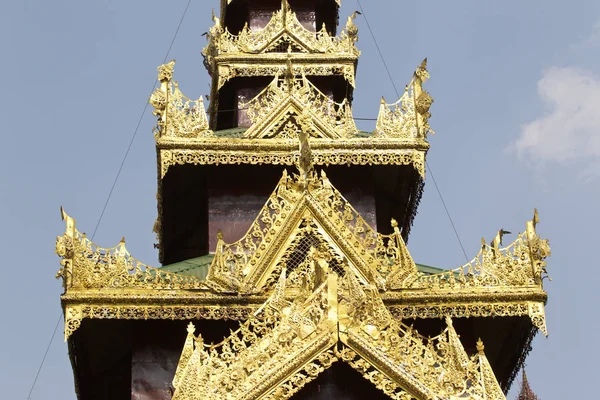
[173,271,337,400]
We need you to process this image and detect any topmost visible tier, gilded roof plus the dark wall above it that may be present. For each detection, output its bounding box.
[202,0,360,89]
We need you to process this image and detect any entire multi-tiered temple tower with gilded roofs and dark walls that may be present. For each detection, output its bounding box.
[56,0,549,400]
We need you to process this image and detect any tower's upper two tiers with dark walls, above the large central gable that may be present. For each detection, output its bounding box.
[150,0,433,264]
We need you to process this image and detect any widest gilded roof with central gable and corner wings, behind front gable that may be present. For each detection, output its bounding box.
[56,173,549,337]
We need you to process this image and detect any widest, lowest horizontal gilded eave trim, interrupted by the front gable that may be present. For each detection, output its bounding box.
[61,288,547,340]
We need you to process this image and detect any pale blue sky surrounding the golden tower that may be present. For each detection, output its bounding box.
[0,0,600,399]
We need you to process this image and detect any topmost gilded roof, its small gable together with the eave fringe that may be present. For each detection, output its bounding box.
[202,1,360,89]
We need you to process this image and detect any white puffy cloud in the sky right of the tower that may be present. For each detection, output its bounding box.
[513,67,600,174]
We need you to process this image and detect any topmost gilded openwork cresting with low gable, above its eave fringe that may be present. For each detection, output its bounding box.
[203,0,360,60]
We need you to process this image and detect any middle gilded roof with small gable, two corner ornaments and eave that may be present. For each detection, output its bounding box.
[150,59,433,179]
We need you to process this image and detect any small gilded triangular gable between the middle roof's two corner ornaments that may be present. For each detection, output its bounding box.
[240,72,358,139]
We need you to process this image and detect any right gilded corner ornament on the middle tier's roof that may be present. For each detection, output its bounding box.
[375,59,434,140]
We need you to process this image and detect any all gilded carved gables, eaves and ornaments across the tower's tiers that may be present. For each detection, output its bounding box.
[56,0,550,400]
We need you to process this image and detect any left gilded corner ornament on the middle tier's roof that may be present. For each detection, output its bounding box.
[149,60,214,140]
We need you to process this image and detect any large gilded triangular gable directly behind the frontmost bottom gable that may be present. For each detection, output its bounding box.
[207,172,417,294]
